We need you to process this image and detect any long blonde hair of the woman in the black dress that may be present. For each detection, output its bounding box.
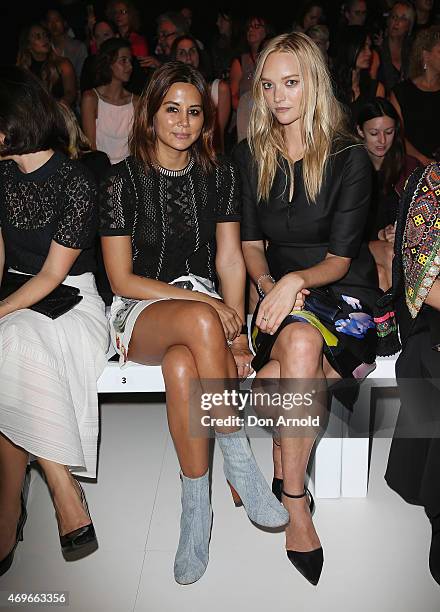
[248,32,348,202]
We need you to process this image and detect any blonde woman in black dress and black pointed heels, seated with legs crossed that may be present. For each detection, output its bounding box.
[235,33,377,585]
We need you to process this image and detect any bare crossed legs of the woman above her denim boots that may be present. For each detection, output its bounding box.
[128,300,237,478]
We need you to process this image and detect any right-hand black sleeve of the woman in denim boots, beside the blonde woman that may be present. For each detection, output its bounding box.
[215,158,241,223]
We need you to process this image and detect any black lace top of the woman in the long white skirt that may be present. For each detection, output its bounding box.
[0,153,97,275]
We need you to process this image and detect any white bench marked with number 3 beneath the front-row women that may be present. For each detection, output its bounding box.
[98,344,397,498]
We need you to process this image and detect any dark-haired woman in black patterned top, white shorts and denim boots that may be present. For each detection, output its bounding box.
[101,62,288,584]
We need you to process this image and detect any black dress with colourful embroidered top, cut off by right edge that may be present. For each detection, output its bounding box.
[385,166,440,519]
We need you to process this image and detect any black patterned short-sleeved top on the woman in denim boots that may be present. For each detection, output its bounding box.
[100,157,240,282]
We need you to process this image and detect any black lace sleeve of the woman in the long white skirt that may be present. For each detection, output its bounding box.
[53,168,98,249]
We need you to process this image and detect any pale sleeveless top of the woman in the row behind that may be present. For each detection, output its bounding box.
[93,89,134,164]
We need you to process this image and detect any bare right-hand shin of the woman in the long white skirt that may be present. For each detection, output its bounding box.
[38,458,90,535]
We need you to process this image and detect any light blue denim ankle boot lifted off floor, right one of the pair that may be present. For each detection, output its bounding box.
[215,429,289,527]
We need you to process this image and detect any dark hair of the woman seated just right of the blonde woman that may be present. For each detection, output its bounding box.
[352,96,405,194]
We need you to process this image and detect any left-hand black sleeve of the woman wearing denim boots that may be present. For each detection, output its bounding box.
[99,160,136,236]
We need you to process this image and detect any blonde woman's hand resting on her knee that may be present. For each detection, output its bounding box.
[256,273,310,334]
